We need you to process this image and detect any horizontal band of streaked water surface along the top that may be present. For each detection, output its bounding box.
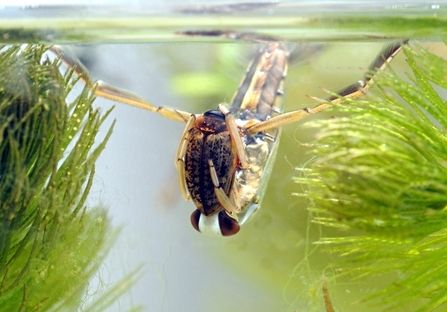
[0,0,446,44]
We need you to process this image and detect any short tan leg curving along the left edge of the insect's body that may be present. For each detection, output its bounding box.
[174,115,196,201]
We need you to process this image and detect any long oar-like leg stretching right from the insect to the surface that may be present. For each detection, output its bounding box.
[245,40,408,134]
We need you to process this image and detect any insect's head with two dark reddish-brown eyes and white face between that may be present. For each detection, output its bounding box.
[191,210,240,236]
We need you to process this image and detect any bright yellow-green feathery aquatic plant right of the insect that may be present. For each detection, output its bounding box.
[297,42,447,311]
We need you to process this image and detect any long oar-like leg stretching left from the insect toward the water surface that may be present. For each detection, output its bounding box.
[50,45,191,123]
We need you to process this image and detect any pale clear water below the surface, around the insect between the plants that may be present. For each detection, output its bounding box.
[71,43,416,311]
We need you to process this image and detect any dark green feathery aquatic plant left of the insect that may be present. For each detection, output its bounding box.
[0,45,139,311]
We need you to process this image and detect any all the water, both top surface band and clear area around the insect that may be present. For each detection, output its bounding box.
[0,2,446,311]
